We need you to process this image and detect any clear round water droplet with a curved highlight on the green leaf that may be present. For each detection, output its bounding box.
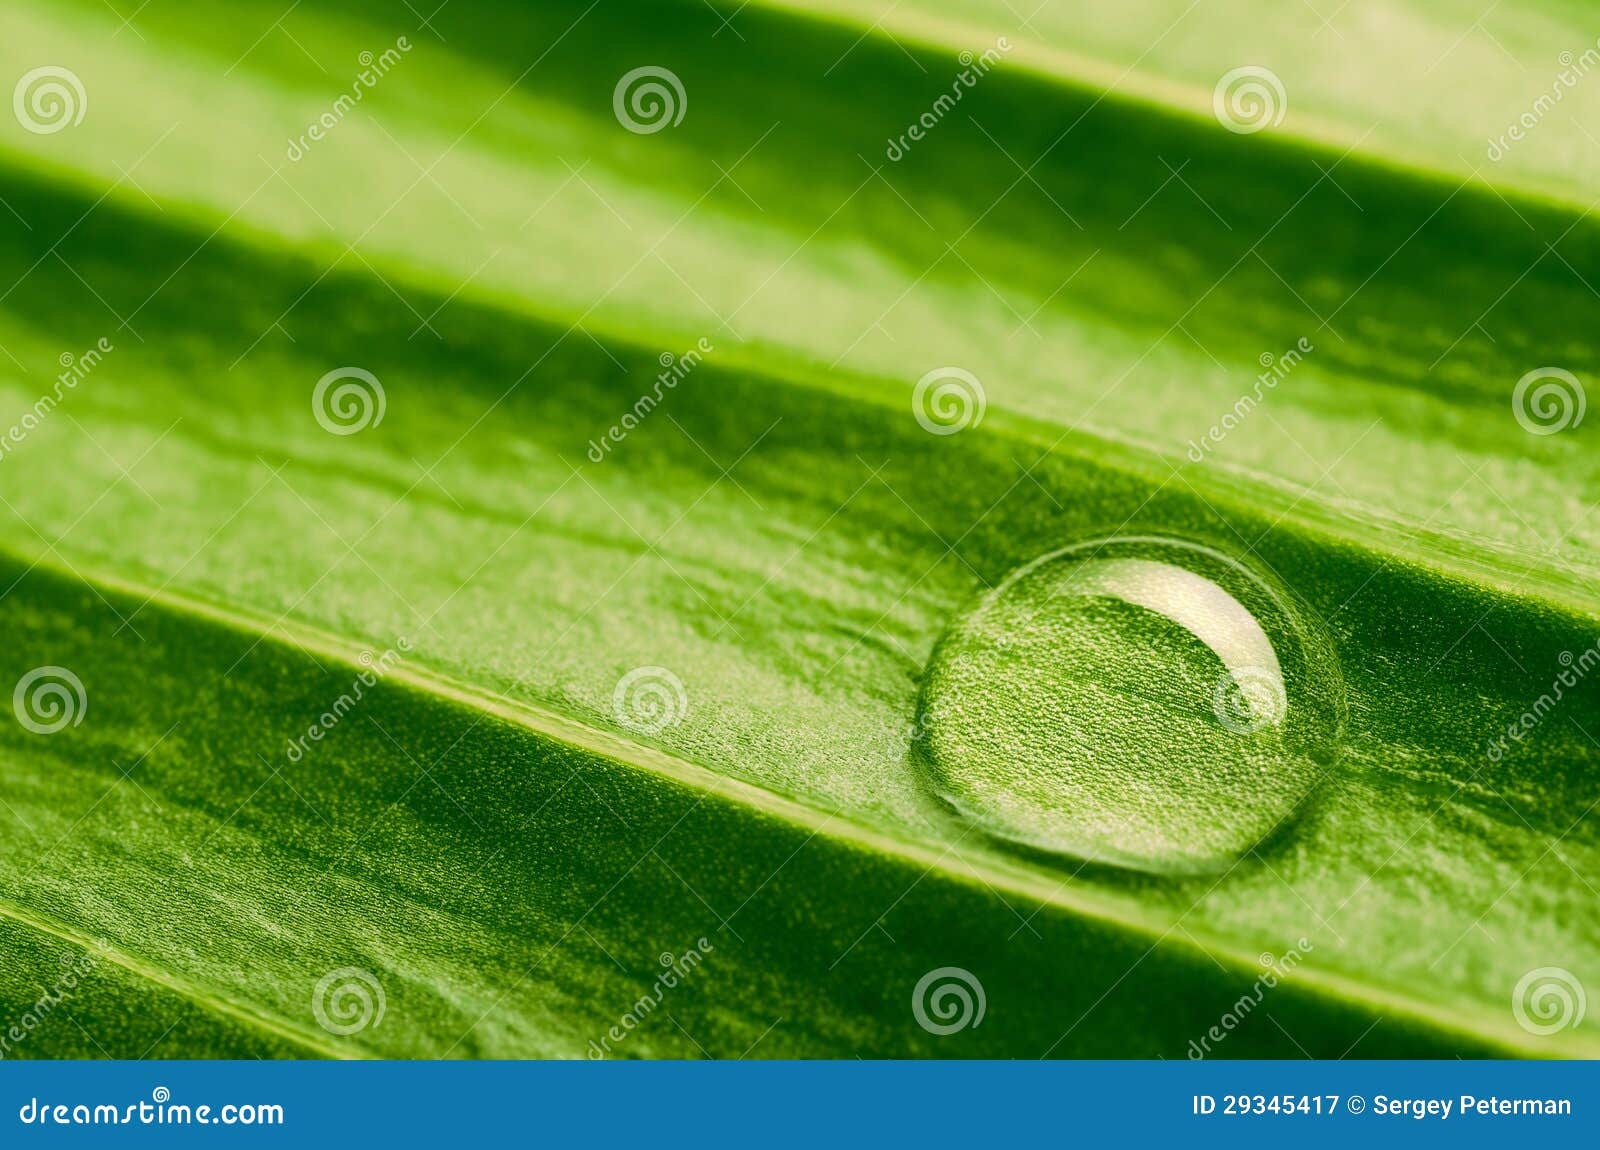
[918,536,1344,873]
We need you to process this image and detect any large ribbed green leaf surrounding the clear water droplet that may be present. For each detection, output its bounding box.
[0,0,1600,1057]
